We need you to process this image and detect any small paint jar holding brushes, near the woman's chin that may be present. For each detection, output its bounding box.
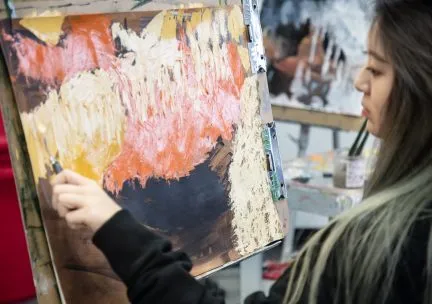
[333,149,366,189]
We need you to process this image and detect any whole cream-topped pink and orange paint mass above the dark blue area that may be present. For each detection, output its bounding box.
[105,9,245,192]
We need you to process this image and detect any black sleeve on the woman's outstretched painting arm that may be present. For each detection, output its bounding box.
[93,210,225,304]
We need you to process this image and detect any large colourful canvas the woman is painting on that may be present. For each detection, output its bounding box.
[1,6,283,303]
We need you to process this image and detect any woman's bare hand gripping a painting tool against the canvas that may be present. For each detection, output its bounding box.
[52,170,121,232]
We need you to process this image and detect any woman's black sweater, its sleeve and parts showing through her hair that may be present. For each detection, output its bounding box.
[93,210,430,304]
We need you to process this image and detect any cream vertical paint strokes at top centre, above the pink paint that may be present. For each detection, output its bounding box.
[112,9,250,122]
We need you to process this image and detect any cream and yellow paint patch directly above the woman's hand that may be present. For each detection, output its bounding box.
[21,70,126,181]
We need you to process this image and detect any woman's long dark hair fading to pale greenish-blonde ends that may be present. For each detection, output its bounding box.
[283,0,432,304]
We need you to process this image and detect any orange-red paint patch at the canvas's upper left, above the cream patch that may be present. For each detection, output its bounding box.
[3,15,116,85]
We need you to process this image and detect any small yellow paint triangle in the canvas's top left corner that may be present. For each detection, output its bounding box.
[19,16,64,45]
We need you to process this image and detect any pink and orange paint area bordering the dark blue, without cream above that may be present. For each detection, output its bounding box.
[104,29,245,193]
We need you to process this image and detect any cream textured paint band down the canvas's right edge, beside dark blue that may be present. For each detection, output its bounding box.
[229,76,283,255]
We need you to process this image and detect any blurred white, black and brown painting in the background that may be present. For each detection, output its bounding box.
[261,0,369,116]
